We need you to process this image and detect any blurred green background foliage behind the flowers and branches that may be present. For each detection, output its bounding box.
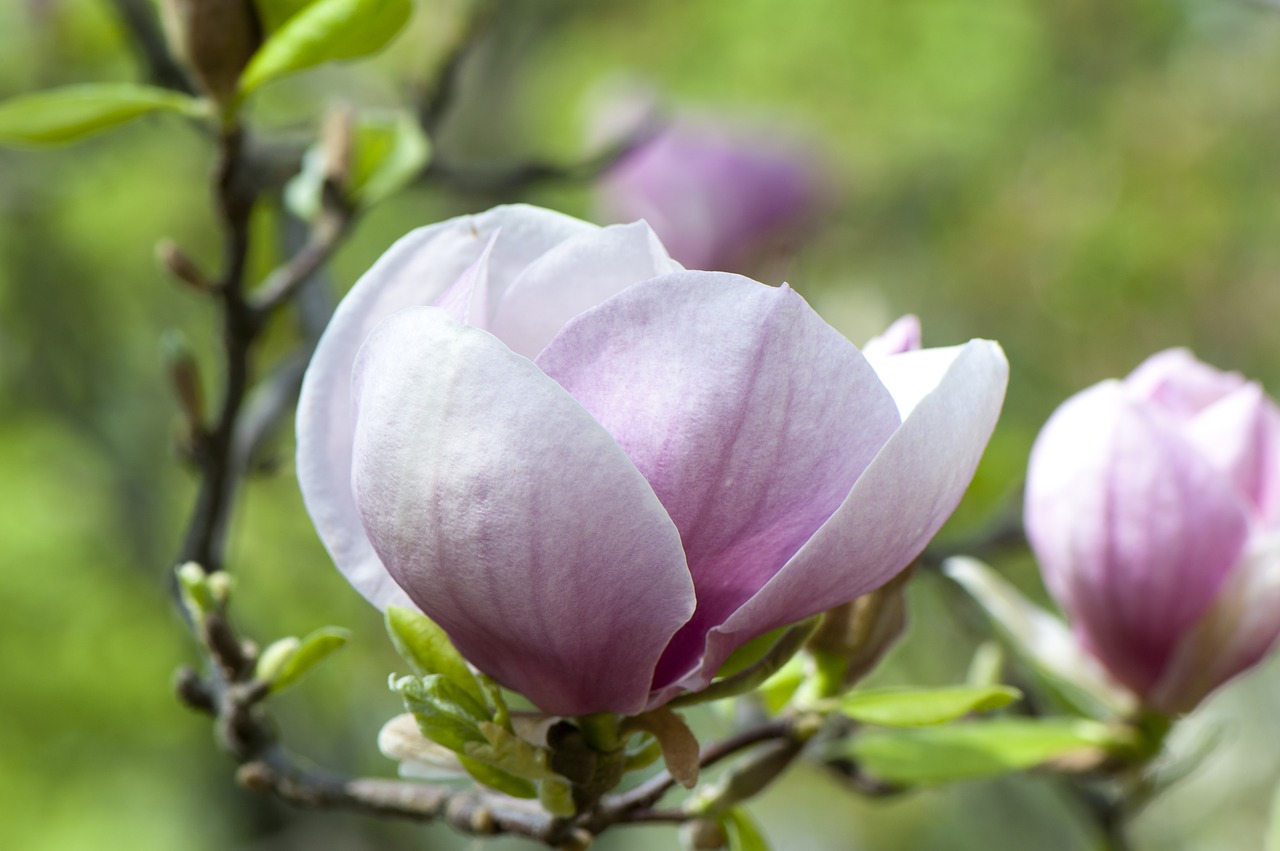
[0,0,1280,851]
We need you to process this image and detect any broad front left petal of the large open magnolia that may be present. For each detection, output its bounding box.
[352,307,694,715]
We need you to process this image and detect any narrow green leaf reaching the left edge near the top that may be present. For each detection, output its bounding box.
[0,83,207,147]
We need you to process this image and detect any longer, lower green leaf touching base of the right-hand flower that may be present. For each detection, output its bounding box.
[837,718,1125,786]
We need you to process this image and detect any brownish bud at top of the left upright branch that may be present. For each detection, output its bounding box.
[164,0,262,104]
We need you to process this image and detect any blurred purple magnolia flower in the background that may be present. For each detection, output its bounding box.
[600,119,820,270]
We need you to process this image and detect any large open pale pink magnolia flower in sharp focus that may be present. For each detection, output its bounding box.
[298,206,1007,715]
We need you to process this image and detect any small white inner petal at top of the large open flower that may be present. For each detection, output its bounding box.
[492,221,681,357]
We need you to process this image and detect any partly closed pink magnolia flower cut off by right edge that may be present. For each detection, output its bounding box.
[1025,349,1280,712]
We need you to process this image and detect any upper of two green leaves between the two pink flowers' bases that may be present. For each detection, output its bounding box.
[836,686,1021,727]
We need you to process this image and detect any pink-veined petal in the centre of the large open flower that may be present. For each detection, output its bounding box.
[538,271,899,685]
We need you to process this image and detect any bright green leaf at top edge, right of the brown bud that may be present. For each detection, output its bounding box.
[239,0,413,95]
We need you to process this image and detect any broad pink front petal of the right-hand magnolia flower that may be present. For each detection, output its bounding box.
[1025,381,1248,695]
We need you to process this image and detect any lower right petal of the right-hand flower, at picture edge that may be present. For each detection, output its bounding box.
[1149,535,1280,712]
